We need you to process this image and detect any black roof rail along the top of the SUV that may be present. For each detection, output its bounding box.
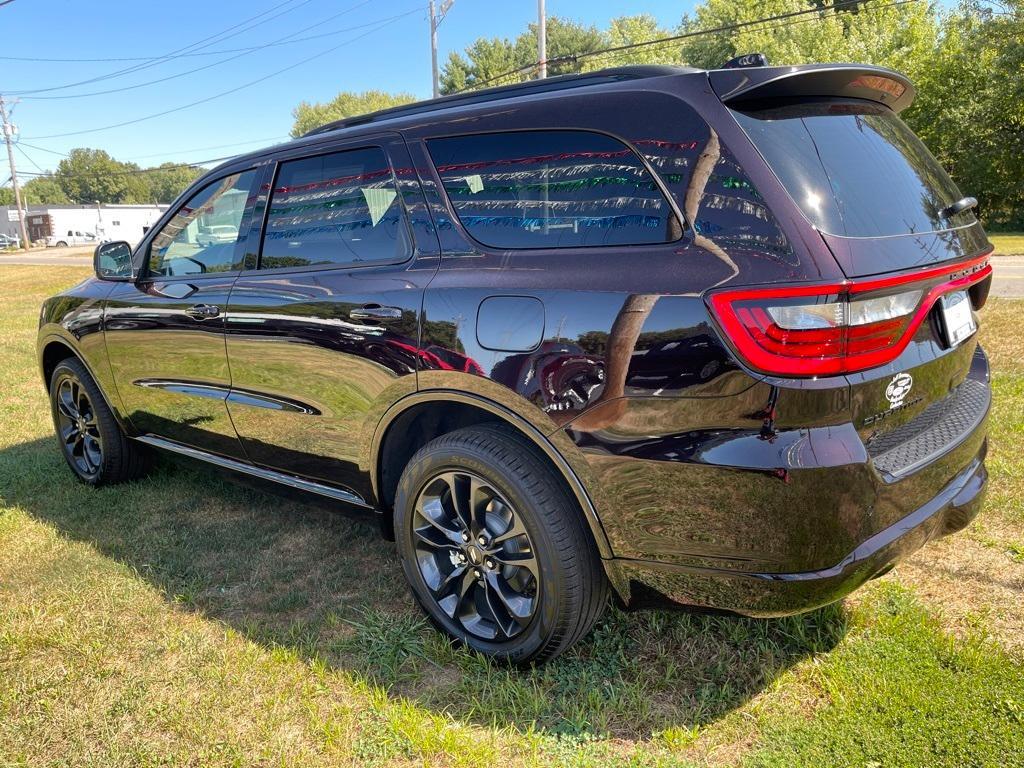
[302,65,700,137]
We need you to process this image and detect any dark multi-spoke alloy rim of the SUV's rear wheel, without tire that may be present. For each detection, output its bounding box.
[412,470,541,641]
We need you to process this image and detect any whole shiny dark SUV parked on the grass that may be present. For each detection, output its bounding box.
[39,65,991,664]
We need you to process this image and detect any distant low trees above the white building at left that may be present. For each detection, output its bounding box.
[0,147,203,205]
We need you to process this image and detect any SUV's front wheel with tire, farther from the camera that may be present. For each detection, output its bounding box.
[50,357,150,485]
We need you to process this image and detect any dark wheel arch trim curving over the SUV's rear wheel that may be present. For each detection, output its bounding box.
[371,389,612,560]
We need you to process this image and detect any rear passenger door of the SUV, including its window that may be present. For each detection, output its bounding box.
[226,134,438,499]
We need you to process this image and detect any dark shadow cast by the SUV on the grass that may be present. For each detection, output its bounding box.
[0,439,846,738]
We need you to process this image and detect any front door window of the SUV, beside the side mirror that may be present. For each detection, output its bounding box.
[148,171,256,276]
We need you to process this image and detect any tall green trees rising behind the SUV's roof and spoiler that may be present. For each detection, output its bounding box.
[292,0,1024,229]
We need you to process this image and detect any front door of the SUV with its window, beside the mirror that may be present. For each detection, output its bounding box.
[105,168,264,457]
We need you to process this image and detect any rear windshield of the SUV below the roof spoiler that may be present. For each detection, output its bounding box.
[733,100,974,238]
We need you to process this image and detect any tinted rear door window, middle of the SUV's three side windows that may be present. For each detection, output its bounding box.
[260,147,412,269]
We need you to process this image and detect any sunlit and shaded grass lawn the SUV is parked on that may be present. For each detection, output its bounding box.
[0,266,1024,768]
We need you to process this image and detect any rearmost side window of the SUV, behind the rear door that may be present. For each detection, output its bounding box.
[427,131,682,248]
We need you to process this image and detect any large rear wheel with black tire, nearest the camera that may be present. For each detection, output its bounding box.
[394,424,608,666]
